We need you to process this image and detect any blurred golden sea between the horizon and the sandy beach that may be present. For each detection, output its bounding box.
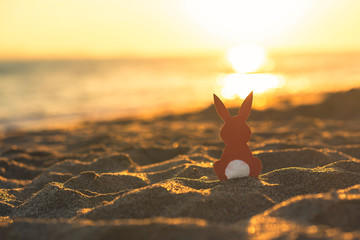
[0,53,360,131]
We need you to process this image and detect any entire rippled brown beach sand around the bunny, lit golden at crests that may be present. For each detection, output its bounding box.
[0,90,360,240]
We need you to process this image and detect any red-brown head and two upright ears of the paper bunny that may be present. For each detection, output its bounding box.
[214,92,253,145]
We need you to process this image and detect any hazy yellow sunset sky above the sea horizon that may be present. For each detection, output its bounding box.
[0,0,360,59]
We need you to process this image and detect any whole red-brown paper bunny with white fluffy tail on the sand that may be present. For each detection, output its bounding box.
[214,92,261,180]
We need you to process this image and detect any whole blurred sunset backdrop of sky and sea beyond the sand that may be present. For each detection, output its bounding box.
[0,0,360,130]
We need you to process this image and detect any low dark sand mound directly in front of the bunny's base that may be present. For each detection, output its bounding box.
[81,179,274,222]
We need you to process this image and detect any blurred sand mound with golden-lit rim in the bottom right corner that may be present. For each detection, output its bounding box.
[249,185,360,239]
